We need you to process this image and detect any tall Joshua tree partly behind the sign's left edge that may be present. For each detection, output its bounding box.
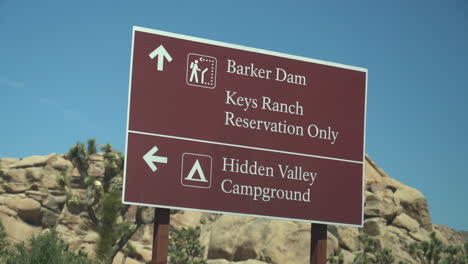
[63,139,144,264]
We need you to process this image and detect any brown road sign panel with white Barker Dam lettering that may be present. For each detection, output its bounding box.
[123,27,367,226]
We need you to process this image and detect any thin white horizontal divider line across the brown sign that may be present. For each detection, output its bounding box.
[127,130,364,164]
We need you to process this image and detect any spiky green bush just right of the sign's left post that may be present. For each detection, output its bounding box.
[169,228,206,264]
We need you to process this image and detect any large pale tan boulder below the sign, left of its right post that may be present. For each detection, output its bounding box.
[208,215,310,264]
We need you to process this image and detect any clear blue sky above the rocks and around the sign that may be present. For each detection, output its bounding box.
[0,0,468,230]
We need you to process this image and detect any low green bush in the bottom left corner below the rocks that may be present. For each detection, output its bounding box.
[0,229,93,264]
